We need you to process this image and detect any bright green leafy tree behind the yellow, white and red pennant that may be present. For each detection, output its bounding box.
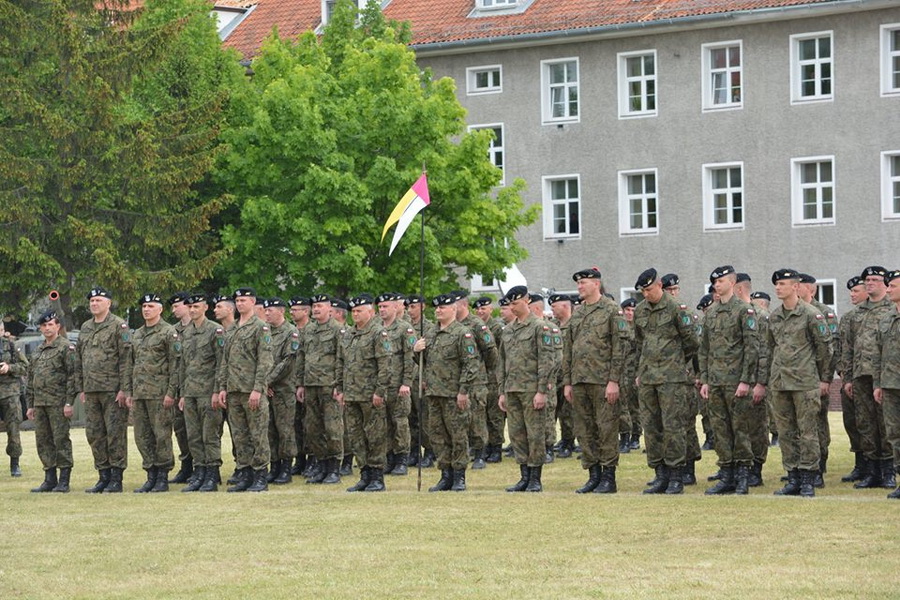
[218,1,537,294]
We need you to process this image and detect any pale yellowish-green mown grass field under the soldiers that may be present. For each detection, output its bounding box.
[0,413,900,600]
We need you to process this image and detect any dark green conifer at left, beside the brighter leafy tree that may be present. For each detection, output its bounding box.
[0,0,244,318]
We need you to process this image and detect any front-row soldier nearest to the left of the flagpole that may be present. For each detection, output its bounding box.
[334,294,393,492]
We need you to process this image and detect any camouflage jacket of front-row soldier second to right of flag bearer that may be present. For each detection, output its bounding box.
[562,297,631,385]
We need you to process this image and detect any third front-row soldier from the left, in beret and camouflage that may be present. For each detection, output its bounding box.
[125,294,181,494]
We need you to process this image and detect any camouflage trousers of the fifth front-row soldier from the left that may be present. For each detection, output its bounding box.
[227,392,271,471]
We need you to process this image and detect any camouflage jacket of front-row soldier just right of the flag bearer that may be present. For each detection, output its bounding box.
[500,314,556,394]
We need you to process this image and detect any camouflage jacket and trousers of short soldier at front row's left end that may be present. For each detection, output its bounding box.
[25,336,75,471]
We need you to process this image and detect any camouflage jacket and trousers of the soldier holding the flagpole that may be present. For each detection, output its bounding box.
[425,321,478,471]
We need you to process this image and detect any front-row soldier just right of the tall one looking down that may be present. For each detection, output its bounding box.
[699,265,759,495]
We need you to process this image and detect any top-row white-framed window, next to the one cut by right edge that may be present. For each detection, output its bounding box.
[791,31,834,103]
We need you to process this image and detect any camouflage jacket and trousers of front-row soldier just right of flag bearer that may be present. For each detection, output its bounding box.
[500,314,556,467]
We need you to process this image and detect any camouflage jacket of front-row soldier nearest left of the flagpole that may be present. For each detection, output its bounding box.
[335,317,394,402]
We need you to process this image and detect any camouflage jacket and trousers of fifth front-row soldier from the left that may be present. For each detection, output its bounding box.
[216,316,273,471]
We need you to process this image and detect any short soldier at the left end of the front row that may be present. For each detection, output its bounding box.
[25,311,75,492]
